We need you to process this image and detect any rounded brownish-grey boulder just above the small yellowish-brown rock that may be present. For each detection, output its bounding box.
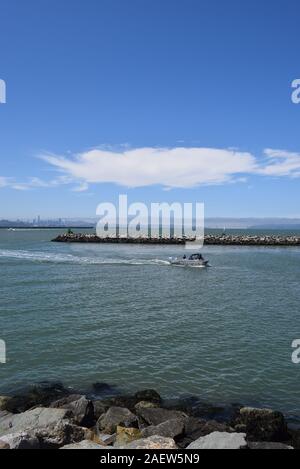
[97,407,138,434]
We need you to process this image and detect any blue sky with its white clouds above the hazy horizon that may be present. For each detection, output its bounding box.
[0,0,300,218]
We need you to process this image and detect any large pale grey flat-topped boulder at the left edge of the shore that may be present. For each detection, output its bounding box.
[0,407,69,439]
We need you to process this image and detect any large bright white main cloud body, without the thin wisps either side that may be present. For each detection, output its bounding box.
[42,148,257,189]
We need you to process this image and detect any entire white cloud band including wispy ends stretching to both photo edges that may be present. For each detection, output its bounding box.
[0,147,300,193]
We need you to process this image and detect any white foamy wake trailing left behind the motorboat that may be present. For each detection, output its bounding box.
[0,249,170,266]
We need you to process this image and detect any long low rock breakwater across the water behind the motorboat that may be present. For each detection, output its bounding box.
[52,233,300,247]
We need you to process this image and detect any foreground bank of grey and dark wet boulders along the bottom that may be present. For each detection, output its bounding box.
[0,382,300,450]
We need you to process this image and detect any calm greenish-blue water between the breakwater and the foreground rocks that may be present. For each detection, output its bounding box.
[0,230,300,415]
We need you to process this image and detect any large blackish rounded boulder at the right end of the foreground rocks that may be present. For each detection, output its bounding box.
[234,407,289,442]
